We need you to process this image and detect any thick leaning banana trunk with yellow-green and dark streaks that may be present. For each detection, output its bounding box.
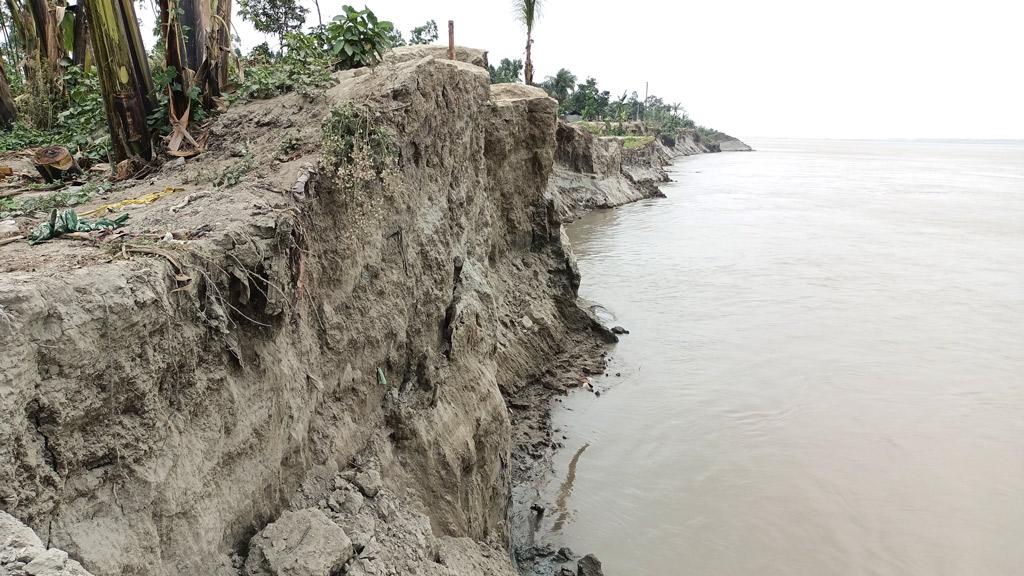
[85,0,155,162]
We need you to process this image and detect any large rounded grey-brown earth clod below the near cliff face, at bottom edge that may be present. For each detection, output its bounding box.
[245,508,353,576]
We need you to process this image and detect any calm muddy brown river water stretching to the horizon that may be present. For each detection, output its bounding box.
[541,140,1024,576]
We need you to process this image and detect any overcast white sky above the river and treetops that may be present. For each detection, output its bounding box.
[138,0,1024,138]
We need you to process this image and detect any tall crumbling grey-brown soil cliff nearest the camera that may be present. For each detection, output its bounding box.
[0,47,602,576]
